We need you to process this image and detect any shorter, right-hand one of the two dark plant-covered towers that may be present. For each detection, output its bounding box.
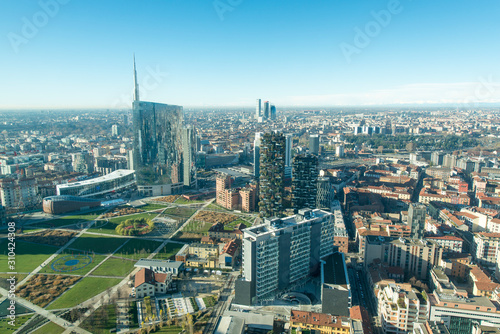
[292,154,318,210]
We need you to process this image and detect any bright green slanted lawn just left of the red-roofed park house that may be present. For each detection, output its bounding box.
[47,277,121,310]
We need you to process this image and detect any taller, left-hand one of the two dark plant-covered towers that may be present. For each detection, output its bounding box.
[259,132,286,217]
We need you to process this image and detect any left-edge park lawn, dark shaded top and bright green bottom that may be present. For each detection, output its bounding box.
[0,239,59,273]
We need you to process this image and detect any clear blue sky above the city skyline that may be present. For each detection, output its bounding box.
[0,0,500,109]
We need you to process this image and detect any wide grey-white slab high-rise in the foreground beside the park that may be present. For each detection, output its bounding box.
[235,209,334,305]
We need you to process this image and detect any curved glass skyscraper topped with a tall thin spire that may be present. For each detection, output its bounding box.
[131,57,186,196]
